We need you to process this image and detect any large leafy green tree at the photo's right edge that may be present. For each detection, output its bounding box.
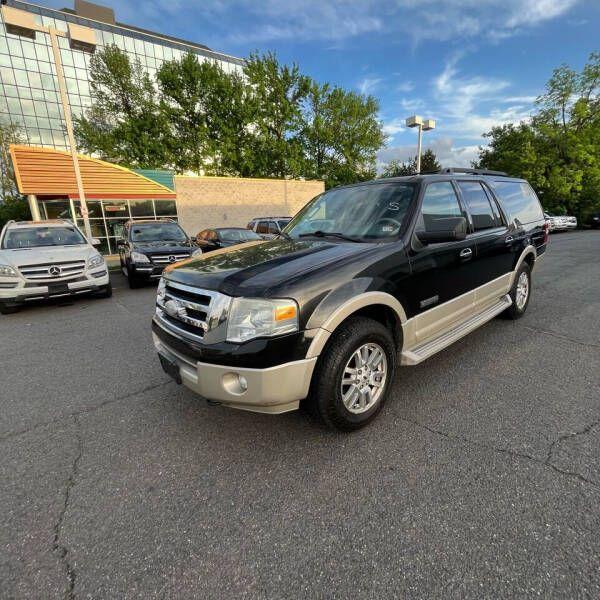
[476,52,600,221]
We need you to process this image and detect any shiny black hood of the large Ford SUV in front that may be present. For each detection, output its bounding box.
[165,238,372,296]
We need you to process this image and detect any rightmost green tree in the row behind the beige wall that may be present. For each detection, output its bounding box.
[299,81,385,187]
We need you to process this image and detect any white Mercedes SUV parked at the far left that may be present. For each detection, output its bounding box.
[0,220,112,314]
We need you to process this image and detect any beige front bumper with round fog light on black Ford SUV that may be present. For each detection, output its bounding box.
[152,333,317,414]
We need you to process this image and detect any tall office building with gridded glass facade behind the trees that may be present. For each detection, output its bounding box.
[0,0,243,149]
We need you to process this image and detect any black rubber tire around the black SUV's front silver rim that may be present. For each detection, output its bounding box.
[305,317,397,431]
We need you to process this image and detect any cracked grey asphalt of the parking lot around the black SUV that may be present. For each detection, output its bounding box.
[0,232,600,598]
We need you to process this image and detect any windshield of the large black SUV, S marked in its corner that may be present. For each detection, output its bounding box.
[285,182,416,241]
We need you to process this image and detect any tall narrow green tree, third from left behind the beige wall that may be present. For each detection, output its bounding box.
[244,53,310,177]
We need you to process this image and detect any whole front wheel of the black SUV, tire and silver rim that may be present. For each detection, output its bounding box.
[307,317,396,431]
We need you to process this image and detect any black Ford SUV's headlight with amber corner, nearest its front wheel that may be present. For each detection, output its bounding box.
[227,298,298,342]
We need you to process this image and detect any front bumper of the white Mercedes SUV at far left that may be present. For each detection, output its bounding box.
[0,265,110,304]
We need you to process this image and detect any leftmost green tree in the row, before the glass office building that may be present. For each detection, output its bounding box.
[75,44,168,168]
